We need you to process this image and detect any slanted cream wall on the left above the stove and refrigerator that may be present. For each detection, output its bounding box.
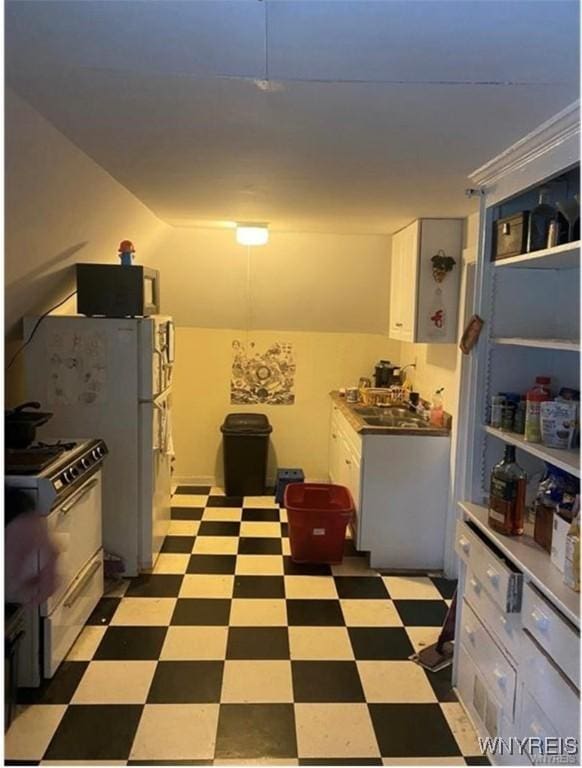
[5,90,168,401]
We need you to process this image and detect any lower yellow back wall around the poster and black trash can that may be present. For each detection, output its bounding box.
[173,327,399,482]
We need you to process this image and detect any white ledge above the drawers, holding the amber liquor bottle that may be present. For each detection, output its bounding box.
[459,501,580,627]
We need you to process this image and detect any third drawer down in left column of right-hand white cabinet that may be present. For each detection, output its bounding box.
[461,600,516,718]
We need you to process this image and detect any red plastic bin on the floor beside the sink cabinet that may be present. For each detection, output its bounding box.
[283,483,354,563]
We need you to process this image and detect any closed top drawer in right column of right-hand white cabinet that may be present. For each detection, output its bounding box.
[522,584,580,690]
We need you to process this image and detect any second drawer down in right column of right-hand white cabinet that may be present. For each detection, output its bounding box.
[519,629,580,737]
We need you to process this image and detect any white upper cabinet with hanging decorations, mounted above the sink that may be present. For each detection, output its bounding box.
[389,219,463,344]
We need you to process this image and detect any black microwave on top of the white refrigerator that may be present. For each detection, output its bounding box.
[77,264,160,317]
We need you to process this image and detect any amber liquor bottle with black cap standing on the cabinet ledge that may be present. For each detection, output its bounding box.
[489,445,527,536]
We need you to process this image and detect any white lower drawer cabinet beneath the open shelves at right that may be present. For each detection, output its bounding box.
[455,521,580,765]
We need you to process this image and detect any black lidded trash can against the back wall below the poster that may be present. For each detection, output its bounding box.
[220,413,273,496]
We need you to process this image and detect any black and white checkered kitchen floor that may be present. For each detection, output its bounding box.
[6,487,487,765]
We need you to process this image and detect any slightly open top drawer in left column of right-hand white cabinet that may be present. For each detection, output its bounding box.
[455,520,523,613]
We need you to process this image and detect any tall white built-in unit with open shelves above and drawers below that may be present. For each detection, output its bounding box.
[453,104,580,766]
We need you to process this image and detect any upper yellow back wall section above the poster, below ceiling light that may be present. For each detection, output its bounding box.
[149,228,390,333]
